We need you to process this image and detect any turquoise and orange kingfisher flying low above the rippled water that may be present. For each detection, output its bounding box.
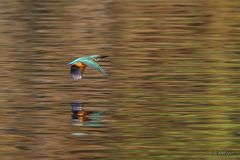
[68,55,108,80]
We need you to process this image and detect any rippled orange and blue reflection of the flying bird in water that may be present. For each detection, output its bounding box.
[71,102,102,127]
